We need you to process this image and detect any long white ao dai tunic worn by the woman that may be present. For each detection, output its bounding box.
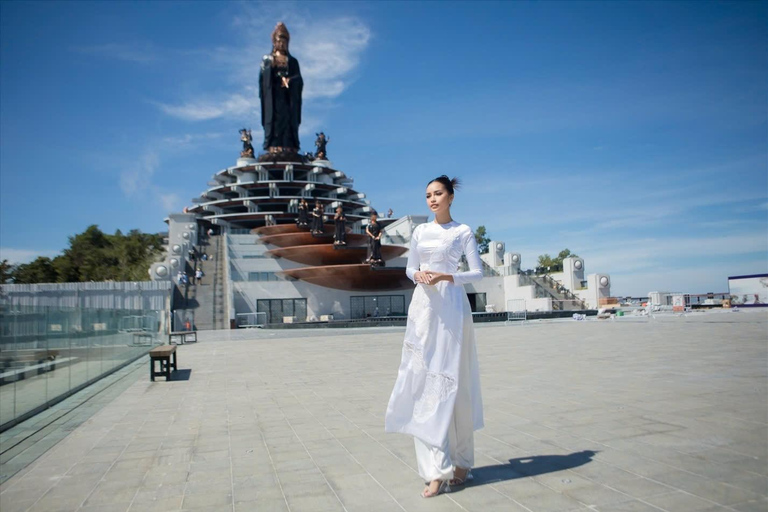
[385,221,483,446]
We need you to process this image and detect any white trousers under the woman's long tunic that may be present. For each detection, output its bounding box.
[413,334,475,482]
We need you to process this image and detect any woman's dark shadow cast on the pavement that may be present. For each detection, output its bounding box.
[470,450,597,486]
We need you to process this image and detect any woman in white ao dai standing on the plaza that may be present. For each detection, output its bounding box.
[385,176,483,498]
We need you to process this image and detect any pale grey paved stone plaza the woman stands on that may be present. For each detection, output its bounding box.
[0,311,768,512]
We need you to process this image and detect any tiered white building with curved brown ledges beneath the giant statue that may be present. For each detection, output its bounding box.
[150,154,610,329]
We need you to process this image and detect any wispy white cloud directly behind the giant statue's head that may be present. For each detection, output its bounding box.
[157,3,371,121]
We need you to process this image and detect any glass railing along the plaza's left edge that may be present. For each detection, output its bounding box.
[0,306,166,430]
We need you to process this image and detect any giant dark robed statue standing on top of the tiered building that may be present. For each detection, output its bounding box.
[259,22,304,158]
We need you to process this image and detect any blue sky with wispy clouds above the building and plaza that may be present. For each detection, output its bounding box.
[0,1,768,295]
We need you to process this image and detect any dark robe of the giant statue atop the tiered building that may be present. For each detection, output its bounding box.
[259,54,304,150]
